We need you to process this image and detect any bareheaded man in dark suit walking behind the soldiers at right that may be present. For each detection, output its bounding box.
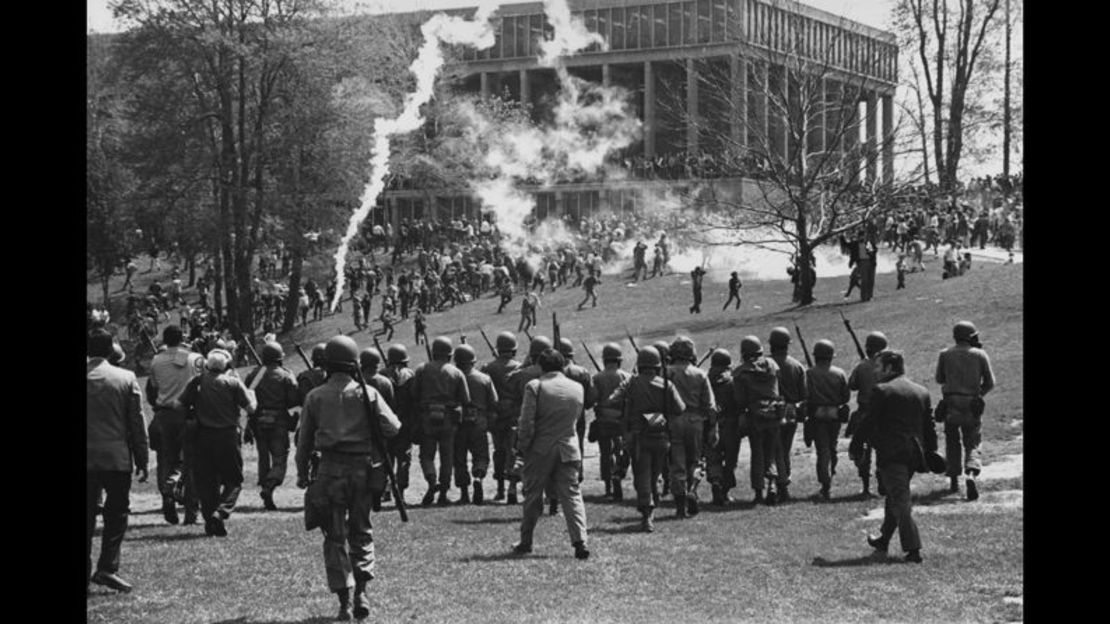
[849,351,937,563]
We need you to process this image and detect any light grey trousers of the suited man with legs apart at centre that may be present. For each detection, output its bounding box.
[521,449,586,544]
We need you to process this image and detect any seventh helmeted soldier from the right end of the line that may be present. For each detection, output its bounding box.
[667,336,718,517]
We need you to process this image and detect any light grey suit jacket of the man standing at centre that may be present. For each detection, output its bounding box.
[516,371,584,463]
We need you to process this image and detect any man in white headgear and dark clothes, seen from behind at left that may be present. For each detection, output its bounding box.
[181,349,258,537]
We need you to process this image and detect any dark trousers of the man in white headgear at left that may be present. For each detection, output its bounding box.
[193,426,243,519]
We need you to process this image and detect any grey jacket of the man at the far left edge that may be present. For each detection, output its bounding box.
[84,358,148,472]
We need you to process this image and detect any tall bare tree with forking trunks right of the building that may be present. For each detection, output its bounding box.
[895,0,1001,192]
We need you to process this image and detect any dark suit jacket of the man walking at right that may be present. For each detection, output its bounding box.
[851,375,937,472]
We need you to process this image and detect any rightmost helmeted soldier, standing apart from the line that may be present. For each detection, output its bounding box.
[937,321,995,501]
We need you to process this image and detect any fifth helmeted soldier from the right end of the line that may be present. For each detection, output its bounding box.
[733,335,786,504]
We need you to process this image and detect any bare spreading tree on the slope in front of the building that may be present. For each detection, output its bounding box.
[663,16,910,305]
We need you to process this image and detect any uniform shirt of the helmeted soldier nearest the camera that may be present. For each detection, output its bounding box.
[296,373,401,476]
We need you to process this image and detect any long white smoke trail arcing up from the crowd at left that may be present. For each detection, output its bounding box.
[331,0,498,312]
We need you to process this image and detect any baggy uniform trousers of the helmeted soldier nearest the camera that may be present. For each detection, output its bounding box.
[313,451,374,592]
